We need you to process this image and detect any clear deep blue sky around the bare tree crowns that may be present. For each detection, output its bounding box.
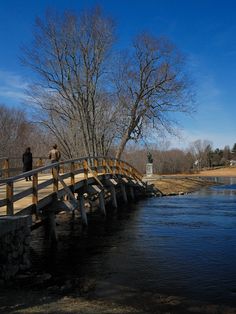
[0,0,236,148]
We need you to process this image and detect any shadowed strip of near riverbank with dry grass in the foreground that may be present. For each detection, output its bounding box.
[0,287,236,314]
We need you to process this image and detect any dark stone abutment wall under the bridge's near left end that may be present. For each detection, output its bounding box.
[0,216,31,281]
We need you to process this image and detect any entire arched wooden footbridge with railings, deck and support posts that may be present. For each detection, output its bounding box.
[0,157,146,225]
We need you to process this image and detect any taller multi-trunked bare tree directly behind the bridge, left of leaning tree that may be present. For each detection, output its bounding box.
[23,9,114,157]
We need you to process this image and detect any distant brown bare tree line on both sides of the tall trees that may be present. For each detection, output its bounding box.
[0,105,236,174]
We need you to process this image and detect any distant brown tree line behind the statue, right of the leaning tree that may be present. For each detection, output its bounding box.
[125,139,236,174]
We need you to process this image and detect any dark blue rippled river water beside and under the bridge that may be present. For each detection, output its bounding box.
[30,179,236,305]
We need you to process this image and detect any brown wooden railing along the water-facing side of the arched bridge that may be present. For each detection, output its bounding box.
[0,157,142,215]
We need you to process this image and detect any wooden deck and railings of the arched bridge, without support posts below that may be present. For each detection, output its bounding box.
[0,157,144,220]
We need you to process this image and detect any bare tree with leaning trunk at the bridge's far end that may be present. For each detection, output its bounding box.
[114,34,192,158]
